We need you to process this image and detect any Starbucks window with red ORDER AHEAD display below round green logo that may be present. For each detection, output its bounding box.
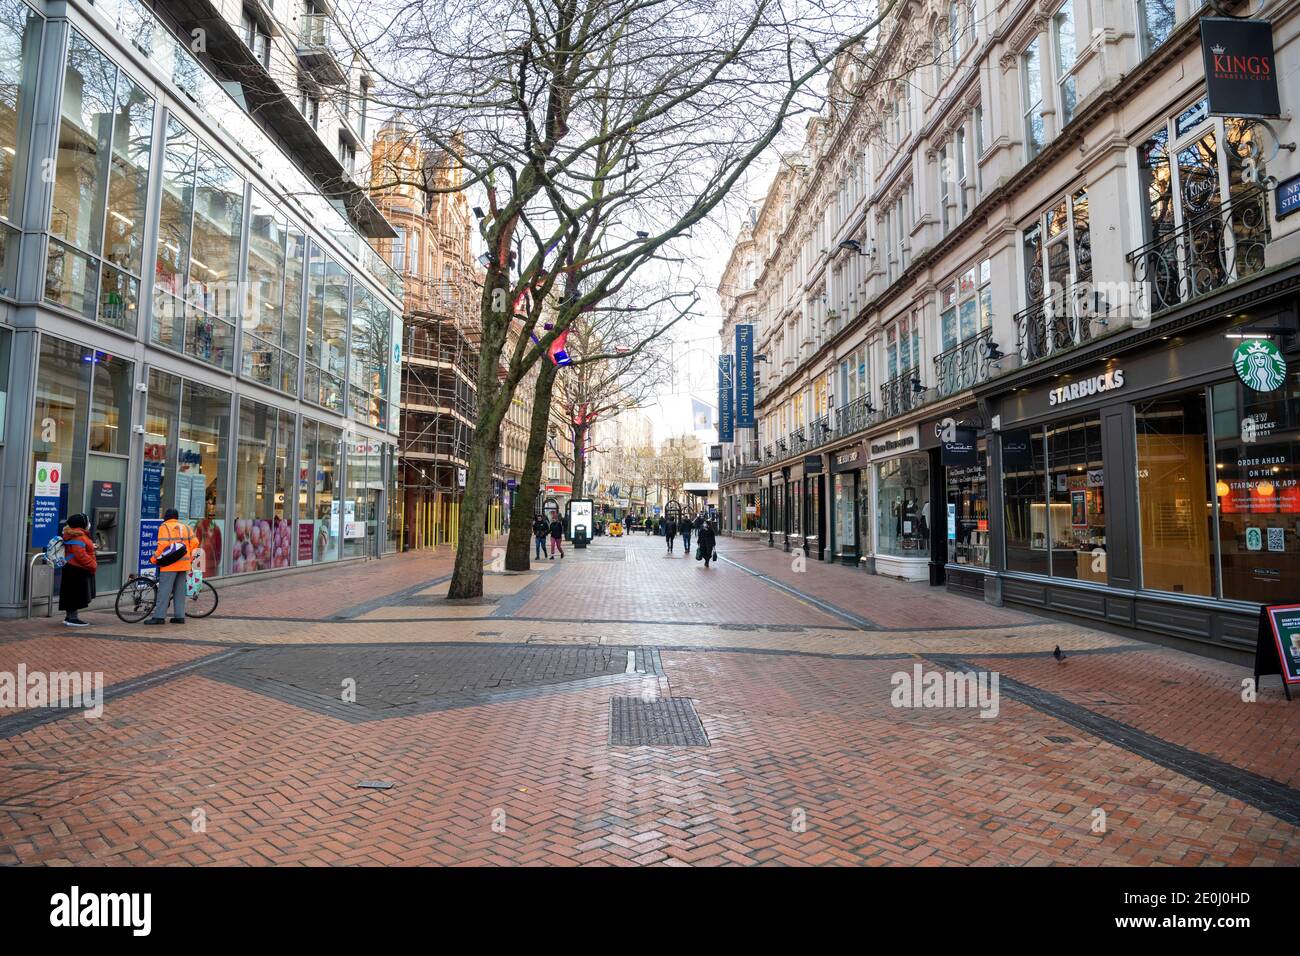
[1210,373,1300,604]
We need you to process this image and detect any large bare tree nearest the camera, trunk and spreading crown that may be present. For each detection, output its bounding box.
[348,0,898,597]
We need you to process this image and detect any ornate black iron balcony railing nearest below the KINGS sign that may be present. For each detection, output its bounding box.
[1128,187,1269,313]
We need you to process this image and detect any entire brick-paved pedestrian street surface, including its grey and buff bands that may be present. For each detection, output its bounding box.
[0,537,1300,865]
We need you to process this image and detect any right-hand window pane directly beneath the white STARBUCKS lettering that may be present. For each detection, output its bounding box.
[1047,418,1106,584]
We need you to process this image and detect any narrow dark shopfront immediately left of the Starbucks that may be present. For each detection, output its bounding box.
[920,405,991,597]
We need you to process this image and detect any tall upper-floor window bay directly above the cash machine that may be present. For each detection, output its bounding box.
[46,30,153,332]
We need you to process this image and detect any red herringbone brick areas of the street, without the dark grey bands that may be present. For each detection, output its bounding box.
[0,538,1300,865]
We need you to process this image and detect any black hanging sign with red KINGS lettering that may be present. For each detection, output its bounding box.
[1201,17,1282,117]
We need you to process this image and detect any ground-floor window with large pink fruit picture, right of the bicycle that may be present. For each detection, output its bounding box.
[230,398,295,574]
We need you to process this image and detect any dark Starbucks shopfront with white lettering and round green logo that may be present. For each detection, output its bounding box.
[982,280,1300,652]
